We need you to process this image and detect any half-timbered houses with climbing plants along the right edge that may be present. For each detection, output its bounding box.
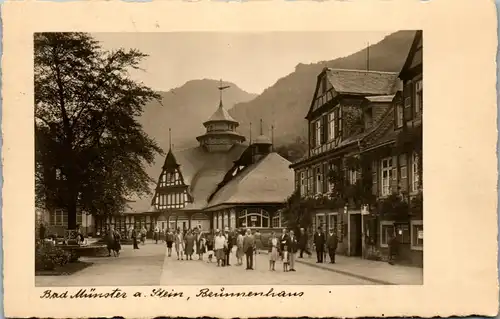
[291,32,423,265]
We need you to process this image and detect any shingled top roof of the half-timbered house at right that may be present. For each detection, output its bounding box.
[326,69,398,95]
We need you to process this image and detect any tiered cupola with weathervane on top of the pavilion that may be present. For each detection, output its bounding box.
[196,80,245,152]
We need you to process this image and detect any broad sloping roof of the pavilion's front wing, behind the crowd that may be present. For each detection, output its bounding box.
[207,153,294,208]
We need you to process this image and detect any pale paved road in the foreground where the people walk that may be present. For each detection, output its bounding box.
[36,243,373,287]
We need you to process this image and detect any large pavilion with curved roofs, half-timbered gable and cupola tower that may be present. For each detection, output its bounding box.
[148,81,294,231]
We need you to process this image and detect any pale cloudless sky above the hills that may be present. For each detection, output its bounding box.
[92,31,394,94]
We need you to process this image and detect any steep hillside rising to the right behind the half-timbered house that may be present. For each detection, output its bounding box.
[229,31,415,144]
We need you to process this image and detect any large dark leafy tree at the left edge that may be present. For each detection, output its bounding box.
[34,33,163,229]
